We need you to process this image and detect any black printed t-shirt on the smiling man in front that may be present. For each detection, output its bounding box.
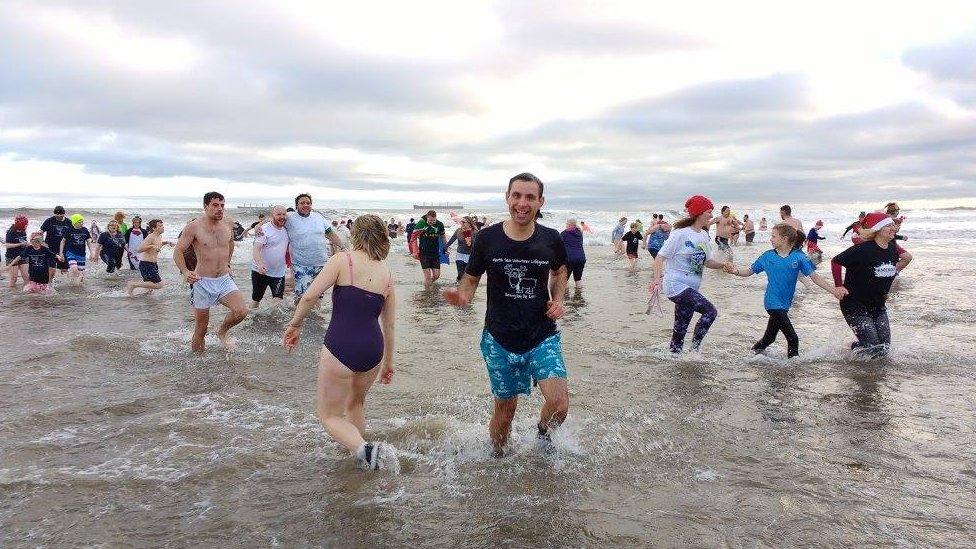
[465,223,566,353]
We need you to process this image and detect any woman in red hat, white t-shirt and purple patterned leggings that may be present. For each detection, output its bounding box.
[649,195,726,353]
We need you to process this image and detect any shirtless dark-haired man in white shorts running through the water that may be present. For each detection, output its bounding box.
[173,192,247,352]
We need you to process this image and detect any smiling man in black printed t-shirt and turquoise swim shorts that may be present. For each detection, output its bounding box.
[444,173,569,456]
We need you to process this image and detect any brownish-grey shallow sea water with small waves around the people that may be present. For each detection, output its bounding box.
[0,206,976,547]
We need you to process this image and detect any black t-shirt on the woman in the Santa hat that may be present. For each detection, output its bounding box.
[834,240,898,307]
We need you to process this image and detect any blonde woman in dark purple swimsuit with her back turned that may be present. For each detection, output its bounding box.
[282,215,396,469]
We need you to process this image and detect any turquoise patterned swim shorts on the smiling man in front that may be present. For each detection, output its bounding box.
[481,330,566,399]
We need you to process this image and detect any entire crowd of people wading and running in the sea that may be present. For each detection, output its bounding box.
[5,178,912,469]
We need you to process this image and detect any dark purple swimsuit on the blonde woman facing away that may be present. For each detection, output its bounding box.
[324,252,392,372]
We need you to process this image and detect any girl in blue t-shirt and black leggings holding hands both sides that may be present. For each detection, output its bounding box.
[726,223,843,358]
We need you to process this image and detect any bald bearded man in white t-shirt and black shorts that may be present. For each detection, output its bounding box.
[251,206,288,309]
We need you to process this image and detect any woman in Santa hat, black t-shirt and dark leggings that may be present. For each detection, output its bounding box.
[832,212,912,358]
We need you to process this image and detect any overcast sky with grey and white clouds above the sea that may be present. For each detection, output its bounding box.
[0,0,976,208]
